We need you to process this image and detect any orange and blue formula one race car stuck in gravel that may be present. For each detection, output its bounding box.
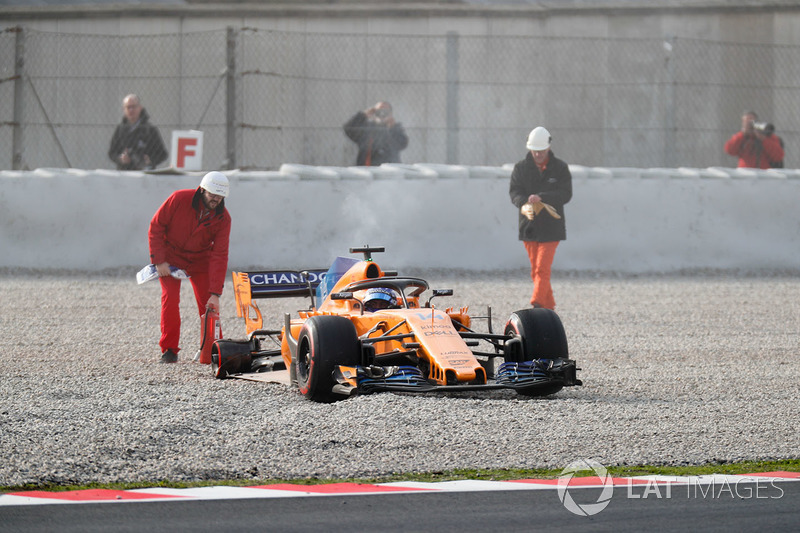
[211,246,582,402]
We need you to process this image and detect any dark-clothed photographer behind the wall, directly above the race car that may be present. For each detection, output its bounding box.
[344,102,408,167]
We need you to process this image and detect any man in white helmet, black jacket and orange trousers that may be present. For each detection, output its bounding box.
[509,126,572,309]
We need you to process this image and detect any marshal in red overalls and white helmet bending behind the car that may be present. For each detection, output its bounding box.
[148,172,231,363]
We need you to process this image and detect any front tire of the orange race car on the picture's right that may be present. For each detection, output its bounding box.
[505,308,569,396]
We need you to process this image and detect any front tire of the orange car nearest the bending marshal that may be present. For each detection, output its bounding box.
[293,315,361,403]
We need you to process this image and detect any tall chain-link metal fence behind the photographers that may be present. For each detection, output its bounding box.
[0,28,800,169]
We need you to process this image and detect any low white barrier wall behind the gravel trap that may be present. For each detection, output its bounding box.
[0,165,800,275]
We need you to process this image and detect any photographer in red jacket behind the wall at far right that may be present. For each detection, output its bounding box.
[725,111,784,169]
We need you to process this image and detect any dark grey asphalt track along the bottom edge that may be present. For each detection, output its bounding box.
[0,476,800,533]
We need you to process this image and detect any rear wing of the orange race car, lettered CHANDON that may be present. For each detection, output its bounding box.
[233,269,327,334]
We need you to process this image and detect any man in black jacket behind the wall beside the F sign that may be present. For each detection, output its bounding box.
[108,94,167,170]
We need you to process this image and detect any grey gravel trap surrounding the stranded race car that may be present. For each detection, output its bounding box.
[0,268,800,486]
